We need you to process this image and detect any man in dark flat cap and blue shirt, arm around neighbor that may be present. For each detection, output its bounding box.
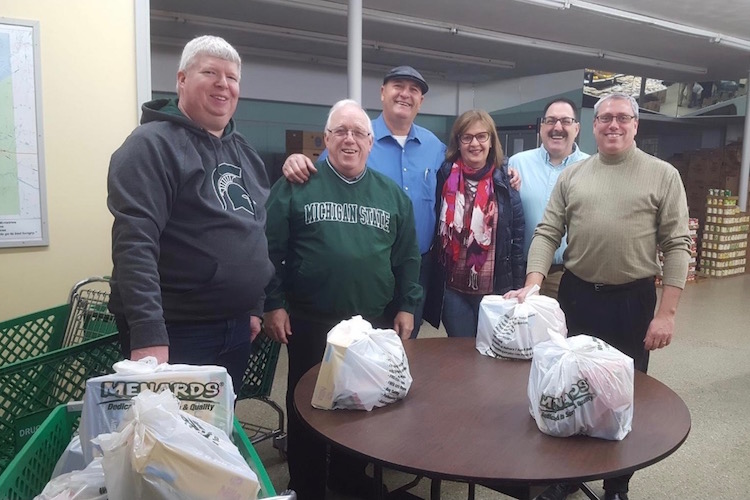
[282,66,445,338]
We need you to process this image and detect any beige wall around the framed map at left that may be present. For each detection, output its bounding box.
[0,0,137,321]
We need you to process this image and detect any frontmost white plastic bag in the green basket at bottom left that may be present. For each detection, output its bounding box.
[94,390,259,500]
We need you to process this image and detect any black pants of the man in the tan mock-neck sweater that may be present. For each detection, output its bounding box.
[558,270,656,492]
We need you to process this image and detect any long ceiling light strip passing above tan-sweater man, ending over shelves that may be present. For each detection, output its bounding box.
[260,0,708,75]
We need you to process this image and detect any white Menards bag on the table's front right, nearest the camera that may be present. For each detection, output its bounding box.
[528,332,633,441]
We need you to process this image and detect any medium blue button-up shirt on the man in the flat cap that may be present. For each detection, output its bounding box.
[320,113,445,253]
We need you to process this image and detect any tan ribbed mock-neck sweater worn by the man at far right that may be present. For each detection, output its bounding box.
[526,146,691,288]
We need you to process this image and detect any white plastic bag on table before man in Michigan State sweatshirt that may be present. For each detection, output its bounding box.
[312,316,412,411]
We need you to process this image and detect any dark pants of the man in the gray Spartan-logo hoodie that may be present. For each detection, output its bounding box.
[115,313,251,394]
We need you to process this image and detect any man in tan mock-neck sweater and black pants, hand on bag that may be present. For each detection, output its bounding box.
[506,94,690,500]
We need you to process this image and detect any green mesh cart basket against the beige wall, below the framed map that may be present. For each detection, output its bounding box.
[0,304,70,367]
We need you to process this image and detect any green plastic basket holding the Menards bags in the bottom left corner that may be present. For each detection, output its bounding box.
[0,405,276,500]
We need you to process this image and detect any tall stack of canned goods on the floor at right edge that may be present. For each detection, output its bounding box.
[700,189,750,278]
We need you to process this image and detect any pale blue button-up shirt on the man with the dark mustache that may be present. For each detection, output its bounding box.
[508,143,589,264]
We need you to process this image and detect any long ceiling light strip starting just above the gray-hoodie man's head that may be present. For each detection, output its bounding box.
[151,10,516,69]
